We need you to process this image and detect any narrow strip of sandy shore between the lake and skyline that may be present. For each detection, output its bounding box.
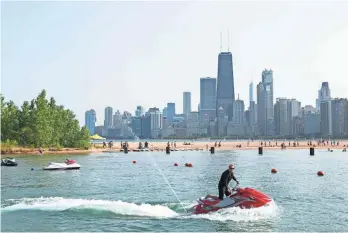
[1,141,348,157]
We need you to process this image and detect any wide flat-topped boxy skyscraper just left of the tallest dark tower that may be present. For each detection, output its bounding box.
[199,77,216,121]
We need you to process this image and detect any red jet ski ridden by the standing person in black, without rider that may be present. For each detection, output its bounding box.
[193,187,272,214]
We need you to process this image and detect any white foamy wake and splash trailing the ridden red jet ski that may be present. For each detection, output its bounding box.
[1,197,279,221]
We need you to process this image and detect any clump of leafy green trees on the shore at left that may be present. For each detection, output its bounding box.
[1,90,89,148]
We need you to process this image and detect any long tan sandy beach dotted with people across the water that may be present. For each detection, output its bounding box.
[1,140,348,156]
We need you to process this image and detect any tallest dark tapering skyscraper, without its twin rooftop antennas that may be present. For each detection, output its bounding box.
[216,52,235,121]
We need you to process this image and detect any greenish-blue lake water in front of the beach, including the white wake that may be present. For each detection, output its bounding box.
[1,149,348,232]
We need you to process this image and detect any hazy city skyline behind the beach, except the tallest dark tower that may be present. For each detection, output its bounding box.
[86,79,348,139]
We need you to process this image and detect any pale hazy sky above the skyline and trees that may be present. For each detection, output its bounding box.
[1,1,348,125]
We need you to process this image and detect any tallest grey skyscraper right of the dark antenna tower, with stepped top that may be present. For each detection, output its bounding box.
[257,69,274,136]
